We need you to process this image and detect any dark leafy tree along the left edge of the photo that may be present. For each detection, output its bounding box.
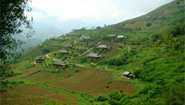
[0,0,31,90]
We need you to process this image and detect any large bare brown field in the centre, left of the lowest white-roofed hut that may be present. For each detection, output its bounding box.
[49,68,137,96]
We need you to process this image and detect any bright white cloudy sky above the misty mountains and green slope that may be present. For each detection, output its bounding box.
[29,0,172,32]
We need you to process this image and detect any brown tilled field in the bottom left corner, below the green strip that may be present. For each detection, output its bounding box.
[0,85,79,105]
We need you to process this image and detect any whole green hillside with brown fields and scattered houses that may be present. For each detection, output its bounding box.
[0,0,185,105]
